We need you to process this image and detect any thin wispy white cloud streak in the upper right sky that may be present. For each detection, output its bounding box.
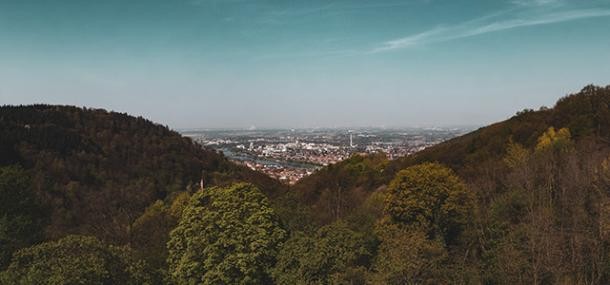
[369,4,610,53]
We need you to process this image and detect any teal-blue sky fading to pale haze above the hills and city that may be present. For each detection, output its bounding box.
[0,0,610,129]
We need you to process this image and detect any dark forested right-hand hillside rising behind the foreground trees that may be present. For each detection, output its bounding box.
[292,86,610,223]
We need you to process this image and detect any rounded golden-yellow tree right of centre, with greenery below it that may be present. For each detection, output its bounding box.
[369,163,475,284]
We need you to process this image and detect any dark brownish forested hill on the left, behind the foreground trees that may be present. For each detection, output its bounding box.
[0,105,282,243]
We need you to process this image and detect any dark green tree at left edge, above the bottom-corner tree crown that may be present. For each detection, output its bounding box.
[0,166,44,270]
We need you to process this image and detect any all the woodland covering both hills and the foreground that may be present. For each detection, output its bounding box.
[0,86,610,285]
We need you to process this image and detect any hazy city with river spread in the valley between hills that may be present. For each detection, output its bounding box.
[182,127,472,184]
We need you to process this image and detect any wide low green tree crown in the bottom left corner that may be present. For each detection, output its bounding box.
[0,236,151,285]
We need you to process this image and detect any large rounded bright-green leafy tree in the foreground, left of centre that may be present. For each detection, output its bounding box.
[167,183,287,284]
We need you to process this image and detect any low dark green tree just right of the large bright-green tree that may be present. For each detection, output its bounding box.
[273,222,371,284]
